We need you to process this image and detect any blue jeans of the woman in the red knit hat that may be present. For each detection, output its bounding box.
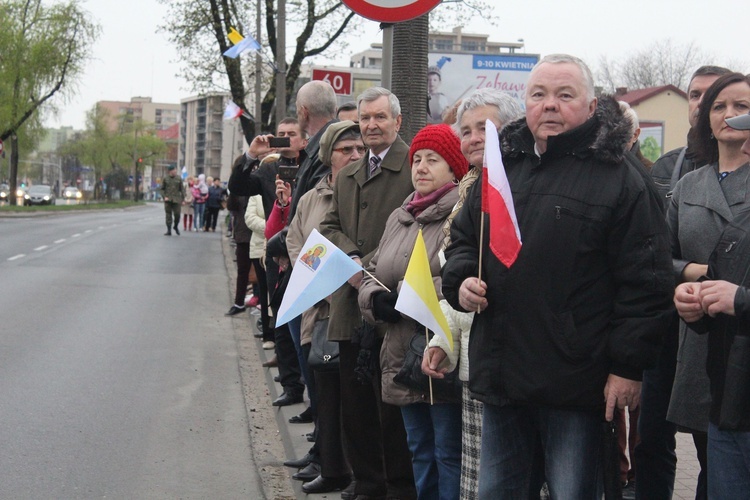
[401,403,461,500]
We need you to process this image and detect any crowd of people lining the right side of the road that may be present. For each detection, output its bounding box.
[219,55,750,500]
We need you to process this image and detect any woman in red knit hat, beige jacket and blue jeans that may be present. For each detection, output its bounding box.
[359,125,469,499]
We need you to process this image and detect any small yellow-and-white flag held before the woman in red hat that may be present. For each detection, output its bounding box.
[396,229,453,350]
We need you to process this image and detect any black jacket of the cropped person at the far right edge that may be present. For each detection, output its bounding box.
[690,210,750,432]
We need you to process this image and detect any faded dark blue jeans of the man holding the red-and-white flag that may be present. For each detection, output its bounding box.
[479,404,603,500]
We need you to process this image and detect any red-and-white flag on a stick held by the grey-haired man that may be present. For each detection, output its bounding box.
[482,120,521,267]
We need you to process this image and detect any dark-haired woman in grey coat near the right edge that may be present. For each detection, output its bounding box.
[667,73,750,498]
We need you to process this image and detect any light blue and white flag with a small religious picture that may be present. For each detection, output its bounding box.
[276,229,362,326]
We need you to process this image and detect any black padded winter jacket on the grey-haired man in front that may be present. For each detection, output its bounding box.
[442,97,674,409]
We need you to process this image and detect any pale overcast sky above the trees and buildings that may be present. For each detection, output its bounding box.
[45,0,750,129]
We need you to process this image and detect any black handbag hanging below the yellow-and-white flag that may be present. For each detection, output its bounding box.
[393,326,463,403]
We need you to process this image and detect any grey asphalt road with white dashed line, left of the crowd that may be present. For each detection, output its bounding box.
[0,205,265,499]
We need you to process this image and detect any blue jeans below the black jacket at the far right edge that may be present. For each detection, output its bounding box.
[708,424,750,500]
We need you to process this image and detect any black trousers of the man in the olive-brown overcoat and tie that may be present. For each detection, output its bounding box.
[339,341,417,499]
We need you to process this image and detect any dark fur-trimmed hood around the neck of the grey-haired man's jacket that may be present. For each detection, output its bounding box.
[500,95,630,167]
